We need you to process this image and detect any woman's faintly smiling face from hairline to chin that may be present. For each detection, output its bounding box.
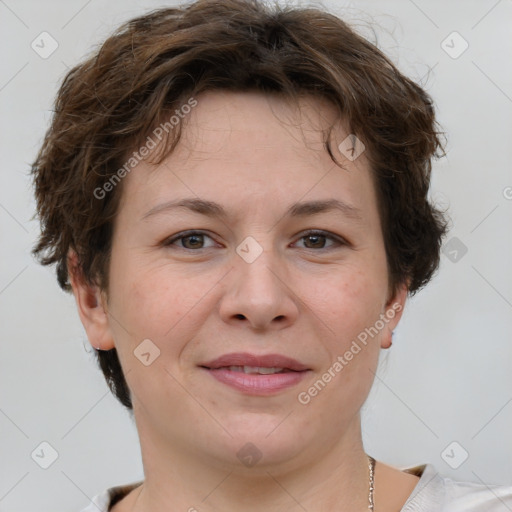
[75,92,405,467]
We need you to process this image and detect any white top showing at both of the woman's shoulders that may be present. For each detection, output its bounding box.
[82,464,512,512]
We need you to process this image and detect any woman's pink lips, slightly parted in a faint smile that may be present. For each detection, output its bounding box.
[200,352,310,396]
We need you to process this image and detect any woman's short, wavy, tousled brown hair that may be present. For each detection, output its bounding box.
[32,0,447,409]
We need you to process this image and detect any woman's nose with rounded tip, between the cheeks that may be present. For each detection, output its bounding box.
[220,244,299,332]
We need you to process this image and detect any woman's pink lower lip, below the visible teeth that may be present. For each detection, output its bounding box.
[206,368,308,395]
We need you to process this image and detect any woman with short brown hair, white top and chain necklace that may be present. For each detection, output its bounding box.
[33,0,512,512]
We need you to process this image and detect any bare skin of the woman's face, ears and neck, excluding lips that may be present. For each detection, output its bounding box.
[70,92,418,512]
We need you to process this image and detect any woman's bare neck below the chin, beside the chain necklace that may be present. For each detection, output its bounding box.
[127,417,369,512]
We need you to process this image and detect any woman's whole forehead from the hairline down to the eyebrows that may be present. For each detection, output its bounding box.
[117,91,375,224]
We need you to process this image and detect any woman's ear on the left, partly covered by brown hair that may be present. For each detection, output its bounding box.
[67,249,115,350]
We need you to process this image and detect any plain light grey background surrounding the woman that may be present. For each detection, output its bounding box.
[0,0,512,512]
